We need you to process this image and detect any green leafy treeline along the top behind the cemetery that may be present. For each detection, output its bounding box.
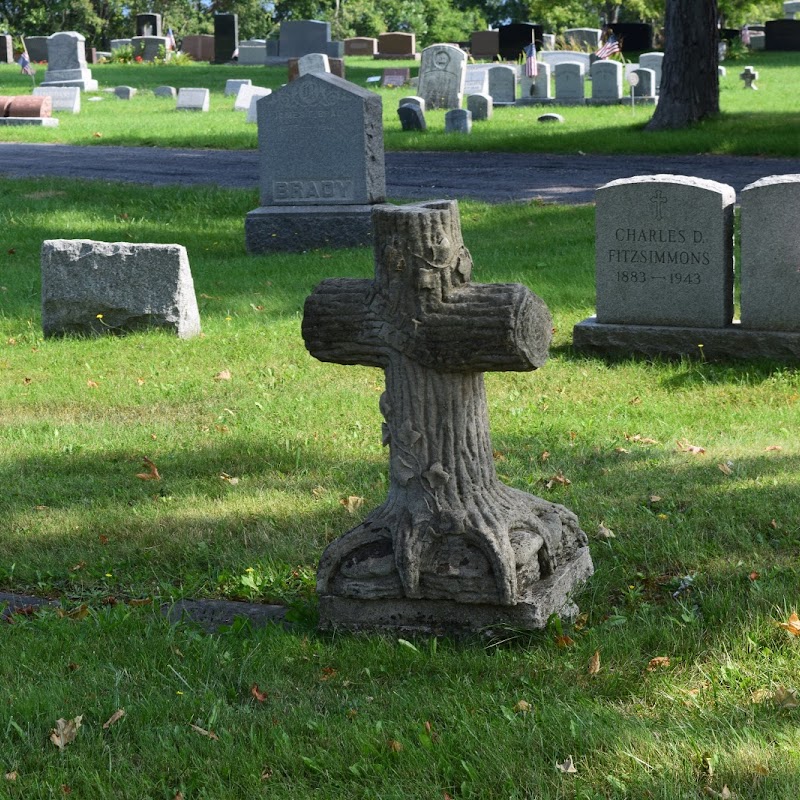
[0,0,782,53]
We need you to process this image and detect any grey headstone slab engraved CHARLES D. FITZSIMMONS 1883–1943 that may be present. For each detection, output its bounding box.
[596,175,735,328]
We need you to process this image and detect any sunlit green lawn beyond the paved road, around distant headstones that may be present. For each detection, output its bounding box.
[0,53,800,157]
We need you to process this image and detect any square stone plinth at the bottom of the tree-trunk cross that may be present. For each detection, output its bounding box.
[319,547,594,636]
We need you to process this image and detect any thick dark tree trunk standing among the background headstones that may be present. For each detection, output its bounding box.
[646,0,719,131]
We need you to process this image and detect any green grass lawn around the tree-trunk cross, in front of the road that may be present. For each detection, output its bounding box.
[0,178,800,800]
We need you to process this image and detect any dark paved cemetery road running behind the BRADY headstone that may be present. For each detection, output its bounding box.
[0,142,800,203]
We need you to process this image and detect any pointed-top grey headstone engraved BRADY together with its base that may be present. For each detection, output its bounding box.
[245,73,386,253]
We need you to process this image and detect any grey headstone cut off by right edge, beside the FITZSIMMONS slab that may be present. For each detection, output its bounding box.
[740,175,800,331]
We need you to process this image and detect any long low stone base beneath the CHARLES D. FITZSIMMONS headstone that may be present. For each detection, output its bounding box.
[572,317,800,364]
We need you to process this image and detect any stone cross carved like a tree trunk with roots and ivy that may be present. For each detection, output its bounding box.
[303,201,592,632]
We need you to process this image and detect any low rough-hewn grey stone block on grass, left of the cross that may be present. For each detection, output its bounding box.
[41,239,200,339]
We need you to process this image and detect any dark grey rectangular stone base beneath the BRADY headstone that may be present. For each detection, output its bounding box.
[244,204,392,253]
